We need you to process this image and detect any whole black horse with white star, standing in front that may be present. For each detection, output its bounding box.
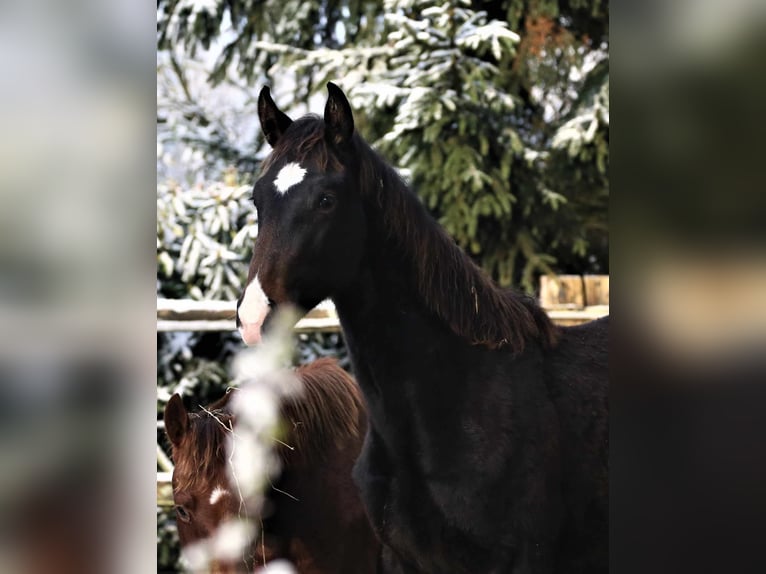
[238,84,608,574]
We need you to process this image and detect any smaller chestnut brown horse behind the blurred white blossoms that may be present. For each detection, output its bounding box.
[165,358,379,574]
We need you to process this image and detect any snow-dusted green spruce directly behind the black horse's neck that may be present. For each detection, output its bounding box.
[358,0,522,284]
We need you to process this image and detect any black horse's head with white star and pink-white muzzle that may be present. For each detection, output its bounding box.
[237,83,366,344]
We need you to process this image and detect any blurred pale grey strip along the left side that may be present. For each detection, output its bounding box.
[0,0,156,574]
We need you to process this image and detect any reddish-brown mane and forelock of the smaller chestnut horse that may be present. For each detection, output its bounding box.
[173,358,366,496]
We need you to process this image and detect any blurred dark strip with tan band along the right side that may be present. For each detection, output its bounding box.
[610,0,766,573]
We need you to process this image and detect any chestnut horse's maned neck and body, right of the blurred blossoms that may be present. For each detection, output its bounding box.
[268,358,379,574]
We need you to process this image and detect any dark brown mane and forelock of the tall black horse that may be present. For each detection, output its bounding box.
[263,115,559,353]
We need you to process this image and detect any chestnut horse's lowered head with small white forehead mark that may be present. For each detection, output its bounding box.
[165,394,239,546]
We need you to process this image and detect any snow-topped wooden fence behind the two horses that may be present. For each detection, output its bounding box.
[157,275,609,507]
